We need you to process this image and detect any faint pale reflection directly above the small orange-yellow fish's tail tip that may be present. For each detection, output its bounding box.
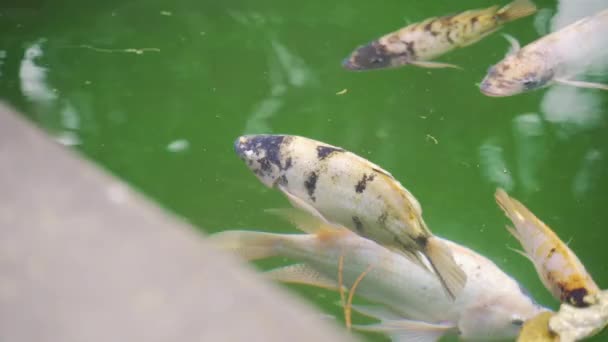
[479,141,514,191]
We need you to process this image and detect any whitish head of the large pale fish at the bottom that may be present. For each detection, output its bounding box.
[458,291,547,340]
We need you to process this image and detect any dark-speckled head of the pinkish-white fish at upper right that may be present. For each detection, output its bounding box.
[479,52,554,97]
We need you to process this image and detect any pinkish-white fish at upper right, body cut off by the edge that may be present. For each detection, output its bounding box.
[480,9,608,96]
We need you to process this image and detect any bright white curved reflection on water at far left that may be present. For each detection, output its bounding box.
[19,40,57,104]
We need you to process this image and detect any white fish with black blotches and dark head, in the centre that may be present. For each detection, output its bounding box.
[235,135,466,298]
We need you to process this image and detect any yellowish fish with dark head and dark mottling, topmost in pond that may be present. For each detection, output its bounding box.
[343,0,536,70]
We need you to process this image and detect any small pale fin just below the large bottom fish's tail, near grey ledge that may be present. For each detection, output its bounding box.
[264,264,338,291]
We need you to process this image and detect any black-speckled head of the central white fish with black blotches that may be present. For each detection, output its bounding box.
[234,134,292,187]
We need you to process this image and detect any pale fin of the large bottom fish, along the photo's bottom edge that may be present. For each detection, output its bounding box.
[353,319,456,342]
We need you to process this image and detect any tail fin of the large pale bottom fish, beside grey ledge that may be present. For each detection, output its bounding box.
[207,230,284,260]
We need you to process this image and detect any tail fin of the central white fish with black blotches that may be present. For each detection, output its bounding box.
[424,237,467,299]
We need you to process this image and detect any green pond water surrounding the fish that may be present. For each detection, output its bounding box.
[0,0,608,341]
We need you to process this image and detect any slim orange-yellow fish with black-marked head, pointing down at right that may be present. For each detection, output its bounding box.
[495,189,599,307]
